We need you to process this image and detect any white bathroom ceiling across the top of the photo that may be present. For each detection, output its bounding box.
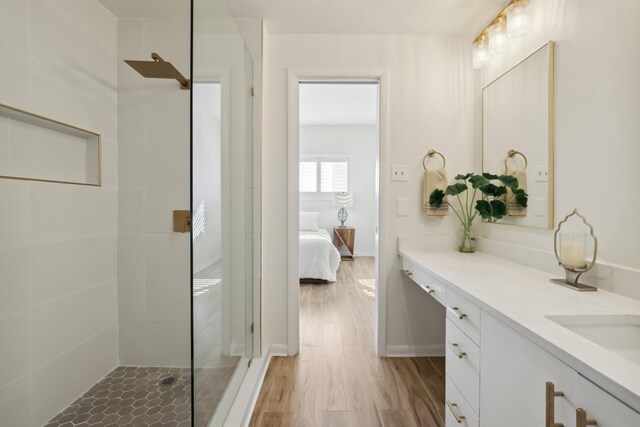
[98,0,508,35]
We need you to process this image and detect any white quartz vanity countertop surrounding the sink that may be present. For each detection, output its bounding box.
[400,250,640,412]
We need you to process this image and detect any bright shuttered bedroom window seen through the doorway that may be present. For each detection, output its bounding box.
[299,158,351,194]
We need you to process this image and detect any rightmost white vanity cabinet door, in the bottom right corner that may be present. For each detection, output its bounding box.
[576,375,640,427]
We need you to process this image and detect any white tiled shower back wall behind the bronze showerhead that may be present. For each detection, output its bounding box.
[117,15,190,366]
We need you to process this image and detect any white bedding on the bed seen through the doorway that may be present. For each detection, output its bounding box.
[298,228,340,282]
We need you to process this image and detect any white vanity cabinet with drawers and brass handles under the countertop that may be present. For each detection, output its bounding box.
[402,252,640,427]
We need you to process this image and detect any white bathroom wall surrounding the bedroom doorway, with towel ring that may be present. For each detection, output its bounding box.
[262,34,475,352]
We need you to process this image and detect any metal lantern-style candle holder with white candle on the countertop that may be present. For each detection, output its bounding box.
[551,209,598,292]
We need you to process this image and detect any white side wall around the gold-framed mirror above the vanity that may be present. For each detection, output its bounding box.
[476,0,640,273]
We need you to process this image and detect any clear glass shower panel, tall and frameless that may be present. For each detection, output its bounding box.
[191,0,255,427]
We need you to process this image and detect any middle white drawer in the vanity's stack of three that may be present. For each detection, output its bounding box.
[445,319,480,414]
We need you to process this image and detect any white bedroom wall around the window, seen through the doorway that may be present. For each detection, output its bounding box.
[300,125,378,256]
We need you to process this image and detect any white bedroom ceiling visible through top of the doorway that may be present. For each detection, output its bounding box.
[300,83,378,126]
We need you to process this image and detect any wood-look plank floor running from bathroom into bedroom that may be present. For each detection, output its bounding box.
[250,257,445,427]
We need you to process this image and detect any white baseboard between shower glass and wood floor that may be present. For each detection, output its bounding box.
[224,344,287,427]
